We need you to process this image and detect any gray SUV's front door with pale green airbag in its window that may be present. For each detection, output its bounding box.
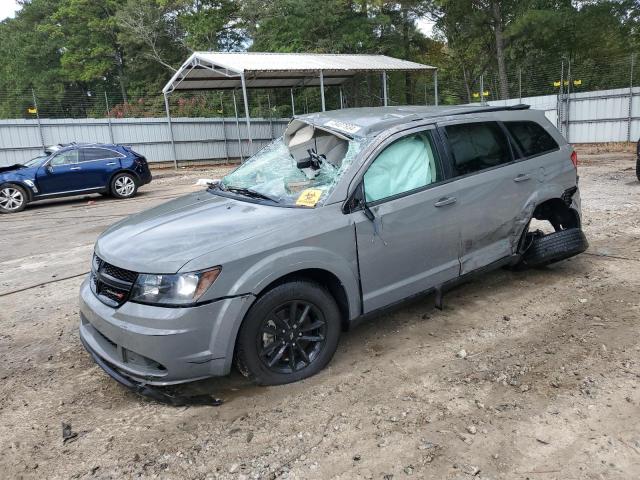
[352,129,460,313]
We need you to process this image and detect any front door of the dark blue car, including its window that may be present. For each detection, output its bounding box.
[37,149,81,195]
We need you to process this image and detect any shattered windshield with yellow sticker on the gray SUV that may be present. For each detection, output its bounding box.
[217,130,365,207]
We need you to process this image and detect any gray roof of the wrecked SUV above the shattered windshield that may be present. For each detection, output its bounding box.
[295,105,529,137]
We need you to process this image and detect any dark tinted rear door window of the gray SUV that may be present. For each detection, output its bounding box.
[445,122,512,176]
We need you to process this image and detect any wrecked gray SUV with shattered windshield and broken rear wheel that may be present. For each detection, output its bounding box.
[80,105,587,385]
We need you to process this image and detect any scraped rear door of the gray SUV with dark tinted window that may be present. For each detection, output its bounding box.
[441,121,536,274]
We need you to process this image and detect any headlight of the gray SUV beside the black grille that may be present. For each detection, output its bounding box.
[130,267,220,305]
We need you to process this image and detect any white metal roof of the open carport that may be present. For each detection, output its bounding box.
[162,52,436,93]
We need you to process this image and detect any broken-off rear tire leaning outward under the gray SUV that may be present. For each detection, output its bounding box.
[522,228,589,267]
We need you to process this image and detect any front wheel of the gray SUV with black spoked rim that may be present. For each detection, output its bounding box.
[236,280,341,385]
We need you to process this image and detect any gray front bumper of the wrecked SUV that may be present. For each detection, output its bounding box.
[80,279,253,385]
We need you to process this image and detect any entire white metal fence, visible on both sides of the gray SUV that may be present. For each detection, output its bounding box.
[0,87,640,166]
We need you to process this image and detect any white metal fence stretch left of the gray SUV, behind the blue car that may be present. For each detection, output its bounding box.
[0,118,288,166]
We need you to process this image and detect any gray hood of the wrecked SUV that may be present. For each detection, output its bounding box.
[96,191,294,273]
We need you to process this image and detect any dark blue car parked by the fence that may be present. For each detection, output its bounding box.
[0,144,151,213]
